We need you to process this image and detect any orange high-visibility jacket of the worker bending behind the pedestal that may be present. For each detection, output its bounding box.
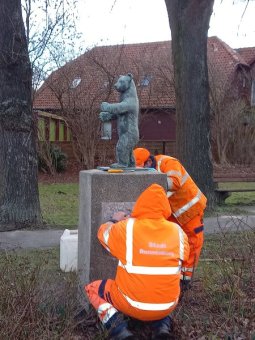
[155,155,207,225]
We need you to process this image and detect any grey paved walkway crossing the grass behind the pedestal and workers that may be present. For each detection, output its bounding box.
[0,214,255,251]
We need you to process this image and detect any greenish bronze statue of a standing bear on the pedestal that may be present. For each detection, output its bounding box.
[99,73,139,168]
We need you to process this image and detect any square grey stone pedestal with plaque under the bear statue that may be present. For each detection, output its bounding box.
[78,170,167,298]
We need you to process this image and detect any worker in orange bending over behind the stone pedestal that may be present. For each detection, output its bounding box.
[134,148,207,290]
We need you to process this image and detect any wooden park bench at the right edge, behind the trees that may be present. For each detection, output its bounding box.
[214,177,255,201]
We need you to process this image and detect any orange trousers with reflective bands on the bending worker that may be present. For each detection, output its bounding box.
[168,215,204,280]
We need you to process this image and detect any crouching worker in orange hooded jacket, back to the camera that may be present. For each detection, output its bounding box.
[84,184,189,340]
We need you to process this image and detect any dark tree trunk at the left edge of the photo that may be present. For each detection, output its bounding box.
[0,0,41,231]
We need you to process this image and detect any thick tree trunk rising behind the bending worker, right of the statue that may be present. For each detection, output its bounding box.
[165,0,216,207]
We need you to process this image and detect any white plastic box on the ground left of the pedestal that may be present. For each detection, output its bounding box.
[60,229,78,272]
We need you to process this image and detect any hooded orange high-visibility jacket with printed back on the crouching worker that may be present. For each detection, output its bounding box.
[98,184,189,320]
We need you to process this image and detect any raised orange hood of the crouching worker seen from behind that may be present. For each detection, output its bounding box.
[131,183,171,219]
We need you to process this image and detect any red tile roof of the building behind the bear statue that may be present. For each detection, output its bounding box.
[34,37,255,110]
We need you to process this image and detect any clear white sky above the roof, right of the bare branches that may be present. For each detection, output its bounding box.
[78,0,255,48]
